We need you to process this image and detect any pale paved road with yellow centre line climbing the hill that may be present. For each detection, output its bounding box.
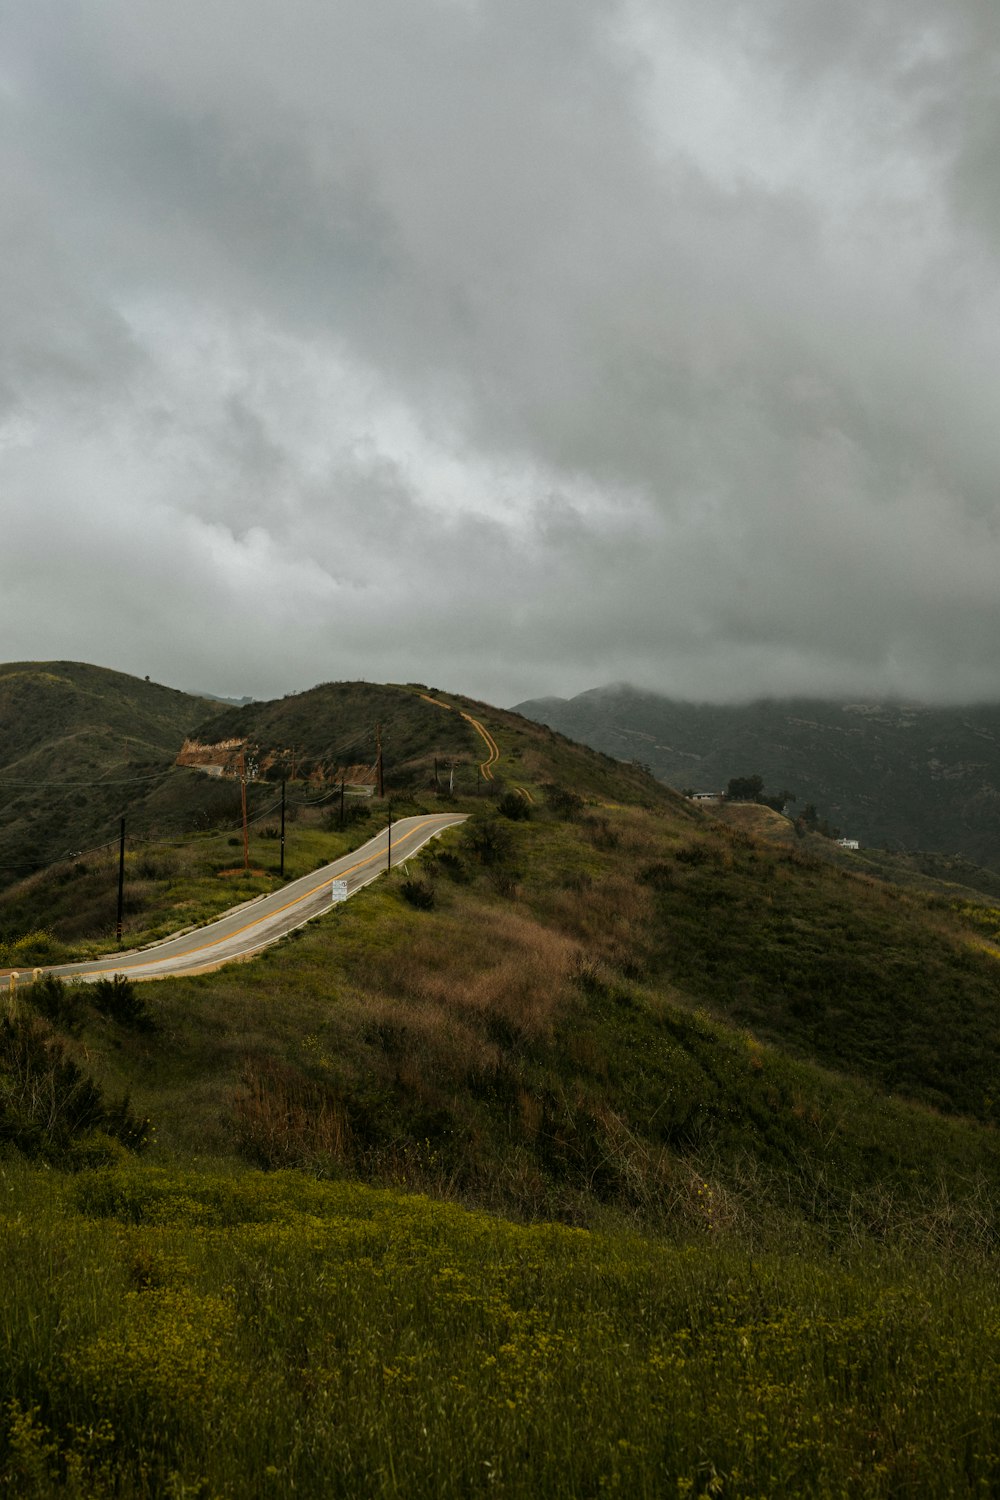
[0,813,466,989]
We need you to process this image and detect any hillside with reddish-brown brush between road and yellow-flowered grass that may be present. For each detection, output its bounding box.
[7,690,1000,1223]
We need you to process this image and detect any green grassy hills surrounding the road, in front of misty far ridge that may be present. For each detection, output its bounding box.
[0,663,1000,1497]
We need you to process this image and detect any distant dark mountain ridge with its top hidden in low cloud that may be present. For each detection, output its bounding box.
[516,684,1000,869]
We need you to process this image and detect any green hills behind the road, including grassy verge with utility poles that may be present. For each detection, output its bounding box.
[0,663,669,965]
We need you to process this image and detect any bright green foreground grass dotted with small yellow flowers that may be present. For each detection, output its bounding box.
[0,1164,1000,1497]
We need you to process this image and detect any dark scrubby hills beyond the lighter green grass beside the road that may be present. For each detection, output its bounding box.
[0,662,611,900]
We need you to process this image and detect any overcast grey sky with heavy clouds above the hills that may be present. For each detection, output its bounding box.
[0,0,1000,704]
